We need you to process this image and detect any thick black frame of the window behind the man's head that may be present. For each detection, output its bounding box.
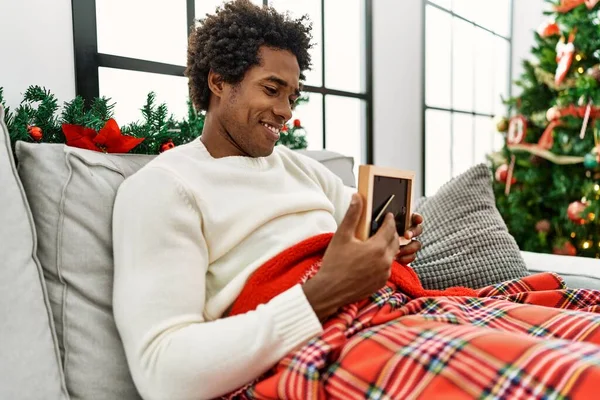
[71,0,373,164]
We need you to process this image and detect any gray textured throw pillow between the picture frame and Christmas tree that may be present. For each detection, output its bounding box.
[411,164,528,289]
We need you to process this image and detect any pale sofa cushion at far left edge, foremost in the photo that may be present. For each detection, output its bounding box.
[0,105,68,399]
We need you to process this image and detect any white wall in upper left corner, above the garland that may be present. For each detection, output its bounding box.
[0,0,75,109]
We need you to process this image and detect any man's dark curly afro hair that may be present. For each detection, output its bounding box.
[185,0,312,110]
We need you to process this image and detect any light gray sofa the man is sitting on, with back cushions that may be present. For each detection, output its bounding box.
[0,106,600,400]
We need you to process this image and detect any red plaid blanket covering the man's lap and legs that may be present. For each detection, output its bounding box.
[227,235,600,400]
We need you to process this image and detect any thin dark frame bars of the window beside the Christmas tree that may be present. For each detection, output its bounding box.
[421,0,515,195]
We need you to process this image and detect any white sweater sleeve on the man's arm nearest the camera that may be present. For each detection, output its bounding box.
[113,167,322,400]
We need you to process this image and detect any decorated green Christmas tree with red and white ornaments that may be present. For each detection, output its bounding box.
[490,0,600,258]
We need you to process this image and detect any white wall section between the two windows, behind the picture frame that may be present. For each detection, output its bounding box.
[373,0,424,198]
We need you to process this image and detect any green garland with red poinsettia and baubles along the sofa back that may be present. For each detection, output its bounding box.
[0,86,308,154]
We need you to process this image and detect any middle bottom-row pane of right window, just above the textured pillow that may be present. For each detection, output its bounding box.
[452,113,473,176]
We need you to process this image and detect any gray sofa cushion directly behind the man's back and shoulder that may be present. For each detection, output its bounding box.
[17,142,153,400]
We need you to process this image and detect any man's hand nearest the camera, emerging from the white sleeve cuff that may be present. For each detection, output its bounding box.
[303,194,399,321]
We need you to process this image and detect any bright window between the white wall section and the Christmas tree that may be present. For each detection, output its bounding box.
[423,0,512,196]
